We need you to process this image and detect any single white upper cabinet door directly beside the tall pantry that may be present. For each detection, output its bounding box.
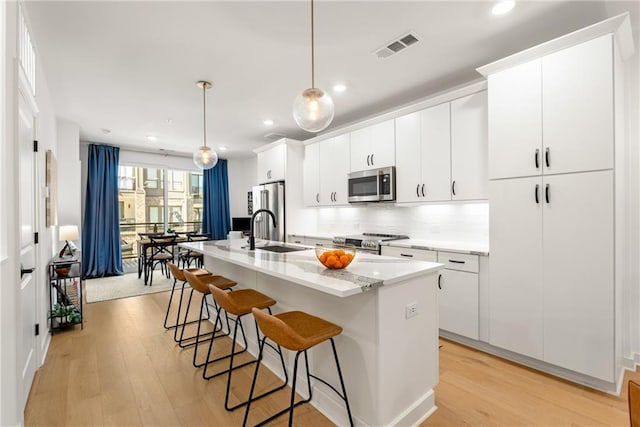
[451,91,489,200]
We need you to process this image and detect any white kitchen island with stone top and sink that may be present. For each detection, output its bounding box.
[181,239,442,426]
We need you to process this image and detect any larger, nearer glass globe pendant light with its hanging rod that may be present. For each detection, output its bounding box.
[293,0,335,132]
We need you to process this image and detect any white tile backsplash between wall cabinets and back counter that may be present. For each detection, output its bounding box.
[310,202,489,242]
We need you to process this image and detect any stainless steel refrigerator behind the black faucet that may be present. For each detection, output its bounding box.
[253,181,286,242]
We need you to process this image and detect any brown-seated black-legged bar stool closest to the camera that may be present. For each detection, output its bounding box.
[242,309,353,426]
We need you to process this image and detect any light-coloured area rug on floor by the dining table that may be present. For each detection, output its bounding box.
[84,271,173,303]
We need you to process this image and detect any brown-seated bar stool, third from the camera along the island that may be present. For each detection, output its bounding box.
[180,270,237,368]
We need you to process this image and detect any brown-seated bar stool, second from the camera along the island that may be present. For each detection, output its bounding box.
[202,285,289,411]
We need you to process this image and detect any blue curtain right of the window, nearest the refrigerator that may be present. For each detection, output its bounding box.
[202,159,231,240]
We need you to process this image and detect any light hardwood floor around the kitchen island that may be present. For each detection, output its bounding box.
[25,292,640,426]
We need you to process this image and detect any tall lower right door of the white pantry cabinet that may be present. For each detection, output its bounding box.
[544,171,616,382]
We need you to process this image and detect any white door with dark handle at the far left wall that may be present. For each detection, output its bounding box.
[16,91,37,414]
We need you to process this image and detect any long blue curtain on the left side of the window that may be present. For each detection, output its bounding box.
[82,144,123,278]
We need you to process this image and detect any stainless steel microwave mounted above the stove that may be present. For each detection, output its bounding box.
[347,166,396,203]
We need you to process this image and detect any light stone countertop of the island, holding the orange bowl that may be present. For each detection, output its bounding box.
[180,239,443,297]
